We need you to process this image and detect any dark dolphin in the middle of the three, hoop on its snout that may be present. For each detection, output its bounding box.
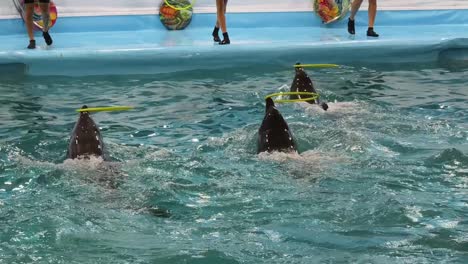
[257,98,297,153]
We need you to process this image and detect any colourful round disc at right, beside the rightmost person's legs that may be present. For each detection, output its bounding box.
[314,0,351,24]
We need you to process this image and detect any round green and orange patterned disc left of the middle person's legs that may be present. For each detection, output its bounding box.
[159,0,193,30]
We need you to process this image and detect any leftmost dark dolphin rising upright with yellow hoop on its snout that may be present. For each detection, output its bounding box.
[67,105,105,159]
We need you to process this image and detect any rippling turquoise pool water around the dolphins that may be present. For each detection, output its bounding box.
[0,66,468,263]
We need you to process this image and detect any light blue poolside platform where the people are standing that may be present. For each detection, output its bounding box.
[0,10,468,75]
